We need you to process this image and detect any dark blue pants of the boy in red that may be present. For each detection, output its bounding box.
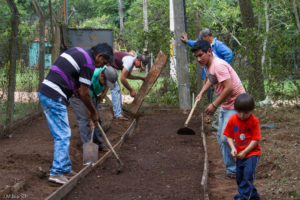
[234,156,260,200]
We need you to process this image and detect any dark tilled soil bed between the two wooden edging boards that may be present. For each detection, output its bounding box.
[65,111,204,200]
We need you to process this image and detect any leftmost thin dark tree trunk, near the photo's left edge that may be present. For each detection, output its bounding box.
[6,0,19,129]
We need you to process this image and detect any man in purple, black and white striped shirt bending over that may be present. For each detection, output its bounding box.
[38,43,113,184]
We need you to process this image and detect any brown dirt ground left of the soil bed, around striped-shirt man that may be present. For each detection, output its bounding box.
[0,104,132,199]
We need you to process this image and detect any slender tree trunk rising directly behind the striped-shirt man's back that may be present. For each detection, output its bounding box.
[32,0,45,85]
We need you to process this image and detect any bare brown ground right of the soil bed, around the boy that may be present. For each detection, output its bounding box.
[207,106,300,200]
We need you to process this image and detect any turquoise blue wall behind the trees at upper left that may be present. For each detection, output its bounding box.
[29,42,52,67]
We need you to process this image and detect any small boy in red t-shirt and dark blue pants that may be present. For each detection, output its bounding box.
[224,93,261,200]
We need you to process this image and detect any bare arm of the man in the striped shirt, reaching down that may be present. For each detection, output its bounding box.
[79,84,98,122]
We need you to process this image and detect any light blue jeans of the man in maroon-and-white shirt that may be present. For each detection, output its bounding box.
[110,81,123,117]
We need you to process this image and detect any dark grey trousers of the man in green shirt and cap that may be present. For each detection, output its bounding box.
[70,96,105,148]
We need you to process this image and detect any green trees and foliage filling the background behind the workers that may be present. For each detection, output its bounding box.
[0,0,300,124]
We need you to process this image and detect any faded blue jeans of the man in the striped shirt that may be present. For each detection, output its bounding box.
[38,92,72,176]
